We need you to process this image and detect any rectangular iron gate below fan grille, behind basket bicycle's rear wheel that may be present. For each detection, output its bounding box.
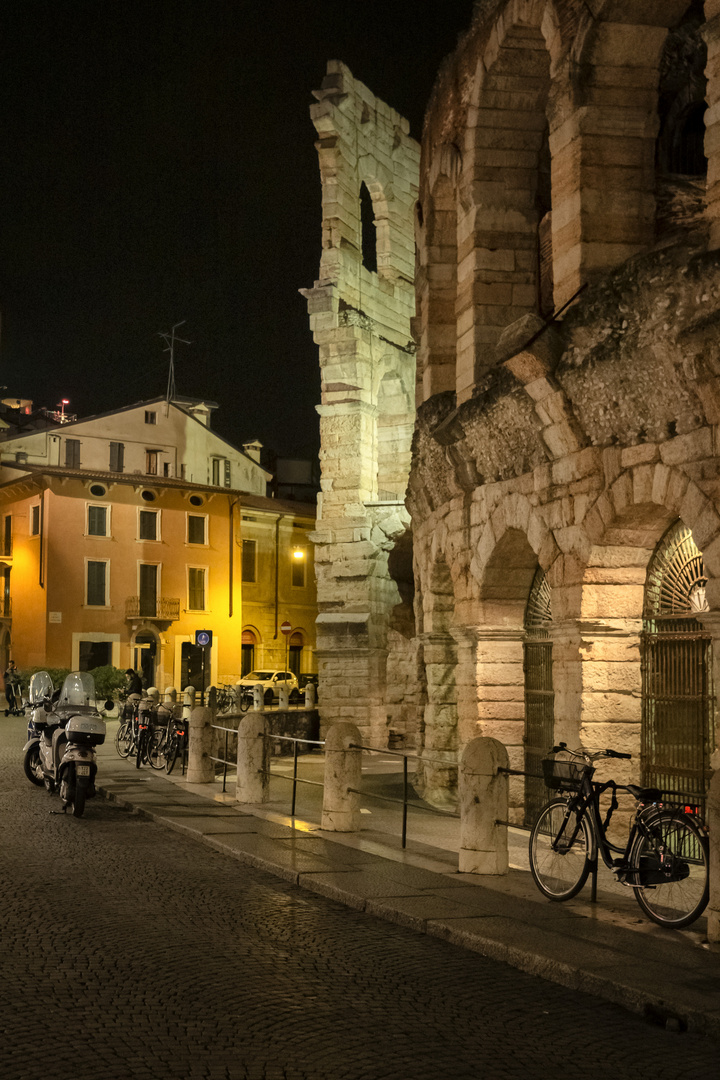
[641,617,715,807]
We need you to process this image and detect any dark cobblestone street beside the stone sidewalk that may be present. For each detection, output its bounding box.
[0,719,720,1080]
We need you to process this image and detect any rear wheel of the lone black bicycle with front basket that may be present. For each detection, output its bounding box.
[629,811,709,930]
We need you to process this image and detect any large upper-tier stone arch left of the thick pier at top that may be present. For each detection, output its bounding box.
[456,0,556,402]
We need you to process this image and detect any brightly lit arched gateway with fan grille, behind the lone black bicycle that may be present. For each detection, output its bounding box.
[641,522,715,805]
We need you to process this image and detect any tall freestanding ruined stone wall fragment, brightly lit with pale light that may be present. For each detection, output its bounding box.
[301,62,421,746]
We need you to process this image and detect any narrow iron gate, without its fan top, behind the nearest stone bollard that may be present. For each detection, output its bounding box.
[524,630,555,825]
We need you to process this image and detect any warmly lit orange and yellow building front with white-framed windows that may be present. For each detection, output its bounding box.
[0,467,316,689]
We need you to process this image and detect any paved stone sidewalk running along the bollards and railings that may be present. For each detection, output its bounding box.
[98,739,720,1038]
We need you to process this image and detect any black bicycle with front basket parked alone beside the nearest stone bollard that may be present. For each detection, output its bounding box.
[530,743,709,930]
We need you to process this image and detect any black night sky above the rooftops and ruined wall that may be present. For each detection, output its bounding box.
[0,0,472,455]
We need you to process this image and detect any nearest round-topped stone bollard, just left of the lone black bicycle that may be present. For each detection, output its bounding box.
[458,738,508,874]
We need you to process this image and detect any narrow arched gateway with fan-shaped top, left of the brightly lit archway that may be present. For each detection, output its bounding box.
[522,567,555,825]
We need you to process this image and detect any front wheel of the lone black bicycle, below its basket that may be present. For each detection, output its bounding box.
[530,799,592,900]
